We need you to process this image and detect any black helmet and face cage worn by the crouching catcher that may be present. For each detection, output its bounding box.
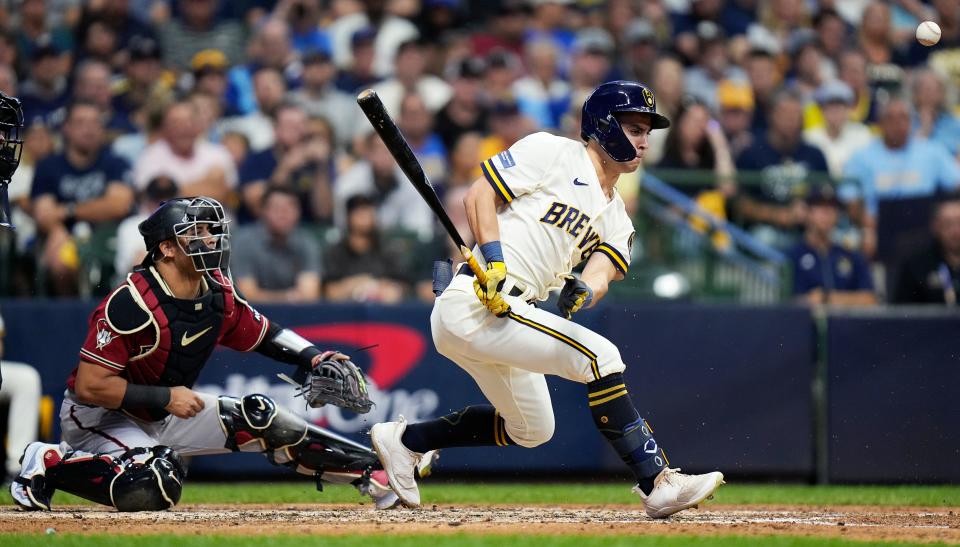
[138,196,230,283]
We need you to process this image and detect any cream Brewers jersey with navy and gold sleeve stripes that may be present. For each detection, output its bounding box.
[478,133,634,300]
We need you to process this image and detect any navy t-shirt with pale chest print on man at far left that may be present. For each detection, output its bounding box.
[30,147,131,203]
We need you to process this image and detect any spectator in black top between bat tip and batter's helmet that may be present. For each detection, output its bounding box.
[434,57,487,149]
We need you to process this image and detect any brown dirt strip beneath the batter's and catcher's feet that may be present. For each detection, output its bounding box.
[0,504,960,544]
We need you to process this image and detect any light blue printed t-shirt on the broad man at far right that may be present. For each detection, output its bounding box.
[841,139,960,215]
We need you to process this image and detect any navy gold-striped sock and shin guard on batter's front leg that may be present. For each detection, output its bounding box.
[587,373,670,494]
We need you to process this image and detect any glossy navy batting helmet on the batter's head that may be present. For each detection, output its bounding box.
[580,80,670,161]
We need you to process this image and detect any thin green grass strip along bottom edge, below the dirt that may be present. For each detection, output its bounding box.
[0,534,943,547]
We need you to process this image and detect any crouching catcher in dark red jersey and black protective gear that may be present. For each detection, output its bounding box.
[10,197,432,511]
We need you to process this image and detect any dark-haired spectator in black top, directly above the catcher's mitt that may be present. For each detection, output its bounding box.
[323,194,409,304]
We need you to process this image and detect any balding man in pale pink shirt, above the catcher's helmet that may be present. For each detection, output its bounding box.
[133,99,237,202]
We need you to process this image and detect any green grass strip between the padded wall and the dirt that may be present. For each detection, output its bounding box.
[47,480,960,507]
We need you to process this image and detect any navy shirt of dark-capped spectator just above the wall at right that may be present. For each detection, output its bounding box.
[787,240,873,295]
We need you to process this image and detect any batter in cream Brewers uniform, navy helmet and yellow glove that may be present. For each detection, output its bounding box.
[371,81,723,518]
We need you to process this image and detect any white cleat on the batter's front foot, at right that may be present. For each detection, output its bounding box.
[633,467,723,519]
